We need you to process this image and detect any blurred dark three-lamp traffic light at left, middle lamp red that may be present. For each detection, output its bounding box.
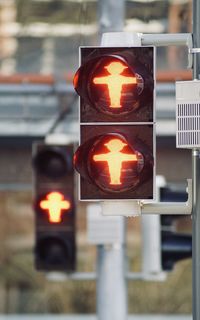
[33,143,76,272]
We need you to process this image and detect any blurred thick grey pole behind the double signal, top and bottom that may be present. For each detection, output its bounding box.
[97,0,127,320]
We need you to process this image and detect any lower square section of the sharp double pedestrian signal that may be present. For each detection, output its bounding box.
[74,125,154,200]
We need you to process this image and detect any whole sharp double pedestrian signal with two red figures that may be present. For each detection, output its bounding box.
[74,47,155,200]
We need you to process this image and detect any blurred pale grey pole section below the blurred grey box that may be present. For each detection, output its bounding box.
[97,244,127,320]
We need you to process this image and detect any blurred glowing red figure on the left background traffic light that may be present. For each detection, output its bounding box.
[40,192,71,223]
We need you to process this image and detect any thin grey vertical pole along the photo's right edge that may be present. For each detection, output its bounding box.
[192,0,200,320]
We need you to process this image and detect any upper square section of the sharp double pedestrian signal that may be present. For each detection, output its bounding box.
[74,47,154,123]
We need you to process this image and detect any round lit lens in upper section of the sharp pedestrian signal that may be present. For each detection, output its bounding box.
[88,57,144,117]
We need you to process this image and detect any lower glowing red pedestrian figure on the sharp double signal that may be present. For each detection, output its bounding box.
[93,139,137,185]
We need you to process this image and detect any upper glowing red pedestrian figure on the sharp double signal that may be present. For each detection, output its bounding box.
[93,62,137,108]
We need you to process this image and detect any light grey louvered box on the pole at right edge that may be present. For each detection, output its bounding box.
[176,80,200,148]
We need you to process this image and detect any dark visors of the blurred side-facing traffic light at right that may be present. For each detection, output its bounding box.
[160,187,192,271]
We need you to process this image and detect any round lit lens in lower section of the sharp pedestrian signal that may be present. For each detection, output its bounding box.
[87,134,144,192]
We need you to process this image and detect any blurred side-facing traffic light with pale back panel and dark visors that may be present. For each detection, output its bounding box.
[142,180,192,278]
